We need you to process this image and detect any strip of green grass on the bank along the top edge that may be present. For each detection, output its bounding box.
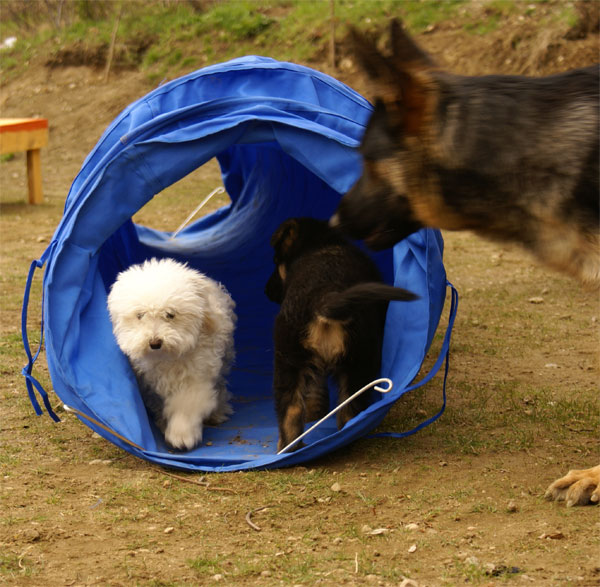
[0,0,465,83]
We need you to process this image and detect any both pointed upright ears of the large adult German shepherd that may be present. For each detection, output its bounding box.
[350,19,435,135]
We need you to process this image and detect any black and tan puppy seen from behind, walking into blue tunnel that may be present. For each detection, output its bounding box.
[265,218,417,450]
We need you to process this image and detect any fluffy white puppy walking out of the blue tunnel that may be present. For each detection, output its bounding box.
[108,259,236,450]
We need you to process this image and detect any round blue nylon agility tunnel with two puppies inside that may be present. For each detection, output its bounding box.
[29,57,446,471]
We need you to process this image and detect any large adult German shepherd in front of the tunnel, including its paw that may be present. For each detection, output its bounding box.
[331,21,600,505]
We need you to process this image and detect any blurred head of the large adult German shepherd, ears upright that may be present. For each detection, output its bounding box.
[331,20,439,250]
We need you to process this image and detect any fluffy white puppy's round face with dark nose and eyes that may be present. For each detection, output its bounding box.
[108,259,210,361]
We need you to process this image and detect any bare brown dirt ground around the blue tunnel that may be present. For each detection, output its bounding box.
[0,4,600,586]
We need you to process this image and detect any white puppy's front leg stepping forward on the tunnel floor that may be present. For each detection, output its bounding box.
[163,383,218,450]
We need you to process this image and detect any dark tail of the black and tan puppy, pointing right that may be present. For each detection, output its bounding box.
[319,281,419,320]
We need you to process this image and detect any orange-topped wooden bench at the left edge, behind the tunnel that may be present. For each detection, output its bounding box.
[0,118,48,204]
